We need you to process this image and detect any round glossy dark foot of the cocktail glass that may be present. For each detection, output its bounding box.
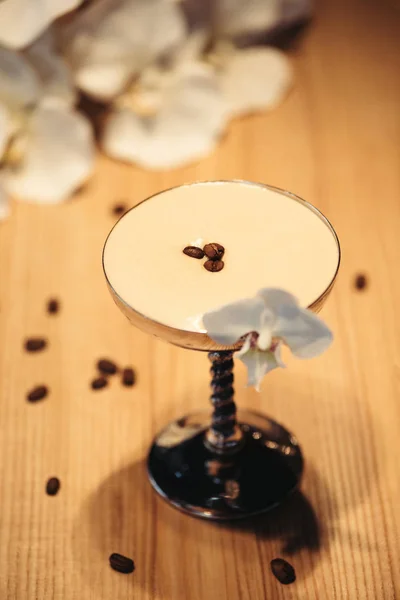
[148,410,303,520]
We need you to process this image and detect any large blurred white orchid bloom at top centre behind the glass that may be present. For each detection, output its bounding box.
[73,0,292,169]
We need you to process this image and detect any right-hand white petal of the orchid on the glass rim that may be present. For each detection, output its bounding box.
[258,289,333,358]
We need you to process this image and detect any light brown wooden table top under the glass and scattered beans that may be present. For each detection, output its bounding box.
[0,0,400,600]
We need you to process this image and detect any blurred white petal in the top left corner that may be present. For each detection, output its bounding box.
[0,0,82,49]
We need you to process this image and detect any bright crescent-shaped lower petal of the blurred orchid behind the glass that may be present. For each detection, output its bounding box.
[103,64,227,169]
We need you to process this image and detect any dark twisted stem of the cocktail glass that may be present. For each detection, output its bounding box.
[205,351,243,454]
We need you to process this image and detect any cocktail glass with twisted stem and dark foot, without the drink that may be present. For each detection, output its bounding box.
[103,181,340,520]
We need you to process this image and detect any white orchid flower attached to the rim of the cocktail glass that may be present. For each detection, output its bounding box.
[203,288,333,390]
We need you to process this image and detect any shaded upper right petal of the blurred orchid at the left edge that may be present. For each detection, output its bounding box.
[24,30,76,107]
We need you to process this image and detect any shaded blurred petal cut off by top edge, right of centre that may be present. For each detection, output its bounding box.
[215,0,280,37]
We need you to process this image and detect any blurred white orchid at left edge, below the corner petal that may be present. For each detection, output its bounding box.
[0,33,94,214]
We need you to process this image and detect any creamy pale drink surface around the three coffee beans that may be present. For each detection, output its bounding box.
[104,182,339,331]
